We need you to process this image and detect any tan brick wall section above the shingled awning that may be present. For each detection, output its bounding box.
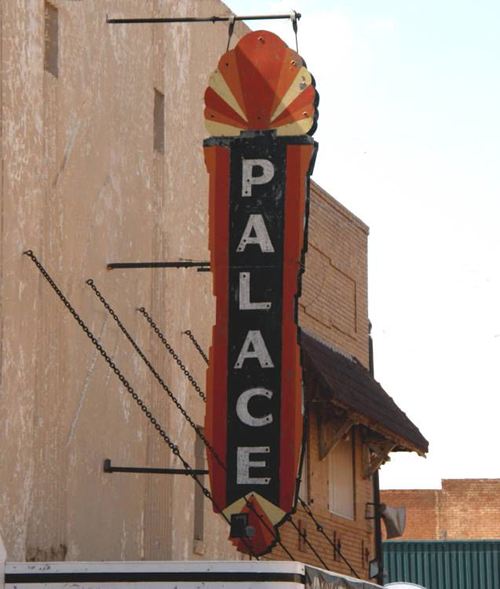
[299,184,368,366]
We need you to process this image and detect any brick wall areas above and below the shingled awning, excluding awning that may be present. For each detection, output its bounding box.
[270,183,374,578]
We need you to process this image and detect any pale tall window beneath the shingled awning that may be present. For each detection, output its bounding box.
[328,431,355,519]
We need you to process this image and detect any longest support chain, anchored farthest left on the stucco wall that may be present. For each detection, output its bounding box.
[24,250,259,560]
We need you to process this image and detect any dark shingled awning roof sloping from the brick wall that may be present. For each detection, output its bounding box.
[300,330,429,455]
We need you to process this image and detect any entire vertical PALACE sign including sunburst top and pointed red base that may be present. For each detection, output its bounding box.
[204,31,318,555]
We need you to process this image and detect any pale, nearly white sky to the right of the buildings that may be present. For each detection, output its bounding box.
[227,0,500,488]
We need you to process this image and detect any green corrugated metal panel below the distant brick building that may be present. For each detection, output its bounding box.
[383,540,500,589]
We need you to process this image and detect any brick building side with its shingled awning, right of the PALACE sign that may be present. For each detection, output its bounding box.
[262,183,427,578]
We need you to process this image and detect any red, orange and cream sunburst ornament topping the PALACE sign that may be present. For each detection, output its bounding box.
[205,31,318,137]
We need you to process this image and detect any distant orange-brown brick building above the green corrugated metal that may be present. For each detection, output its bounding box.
[381,479,500,540]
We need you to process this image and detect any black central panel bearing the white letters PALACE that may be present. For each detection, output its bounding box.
[227,133,286,504]
